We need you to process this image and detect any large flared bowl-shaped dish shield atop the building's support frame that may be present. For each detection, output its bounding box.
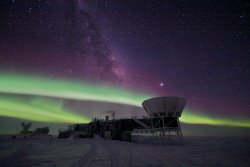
[142,96,186,117]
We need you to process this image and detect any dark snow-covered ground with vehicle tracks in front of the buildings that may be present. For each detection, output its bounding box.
[0,137,250,167]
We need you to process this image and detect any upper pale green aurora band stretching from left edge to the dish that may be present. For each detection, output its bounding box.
[0,74,151,107]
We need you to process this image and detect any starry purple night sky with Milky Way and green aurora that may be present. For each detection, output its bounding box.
[0,0,250,134]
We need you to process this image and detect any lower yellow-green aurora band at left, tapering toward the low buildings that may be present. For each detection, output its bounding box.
[0,97,90,123]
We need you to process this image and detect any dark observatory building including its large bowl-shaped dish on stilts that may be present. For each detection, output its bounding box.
[59,96,186,143]
